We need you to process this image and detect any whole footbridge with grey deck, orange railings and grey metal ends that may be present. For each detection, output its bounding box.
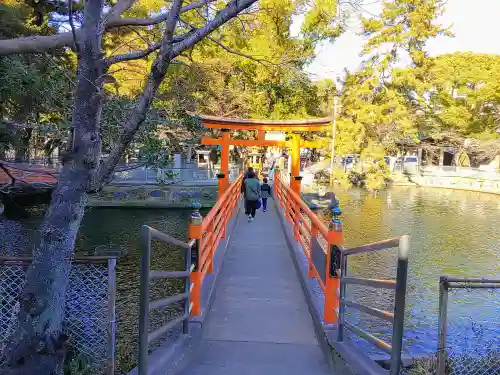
[131,174,408,375]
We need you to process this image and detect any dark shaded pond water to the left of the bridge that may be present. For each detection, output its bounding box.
[0,208,199,373]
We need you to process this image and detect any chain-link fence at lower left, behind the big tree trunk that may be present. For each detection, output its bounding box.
[0,256,116,375]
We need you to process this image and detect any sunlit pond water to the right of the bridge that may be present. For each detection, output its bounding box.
[314,187,500,354]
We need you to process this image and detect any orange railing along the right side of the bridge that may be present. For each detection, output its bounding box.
[274,172,343,323]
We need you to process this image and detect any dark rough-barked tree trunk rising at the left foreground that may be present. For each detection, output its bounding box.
[0,0,104,375]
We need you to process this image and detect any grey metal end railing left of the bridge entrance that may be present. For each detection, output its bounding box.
[139,225,195,375]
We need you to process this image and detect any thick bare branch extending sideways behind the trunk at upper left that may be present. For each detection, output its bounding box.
[0,0,211,56]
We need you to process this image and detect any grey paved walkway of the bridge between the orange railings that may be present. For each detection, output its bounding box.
[181,200,330,375]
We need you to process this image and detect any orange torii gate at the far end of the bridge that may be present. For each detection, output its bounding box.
[196,115,332,196]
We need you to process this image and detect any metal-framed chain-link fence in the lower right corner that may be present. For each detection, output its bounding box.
[437,276,500,375]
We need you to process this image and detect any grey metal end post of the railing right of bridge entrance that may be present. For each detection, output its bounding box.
[389,236,410,375]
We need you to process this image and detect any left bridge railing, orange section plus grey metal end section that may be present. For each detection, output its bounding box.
[138,175,243,375]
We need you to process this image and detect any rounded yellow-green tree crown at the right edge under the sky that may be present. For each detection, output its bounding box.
[394,52,500,137]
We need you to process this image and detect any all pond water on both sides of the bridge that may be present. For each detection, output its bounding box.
[0,187,500,370]
